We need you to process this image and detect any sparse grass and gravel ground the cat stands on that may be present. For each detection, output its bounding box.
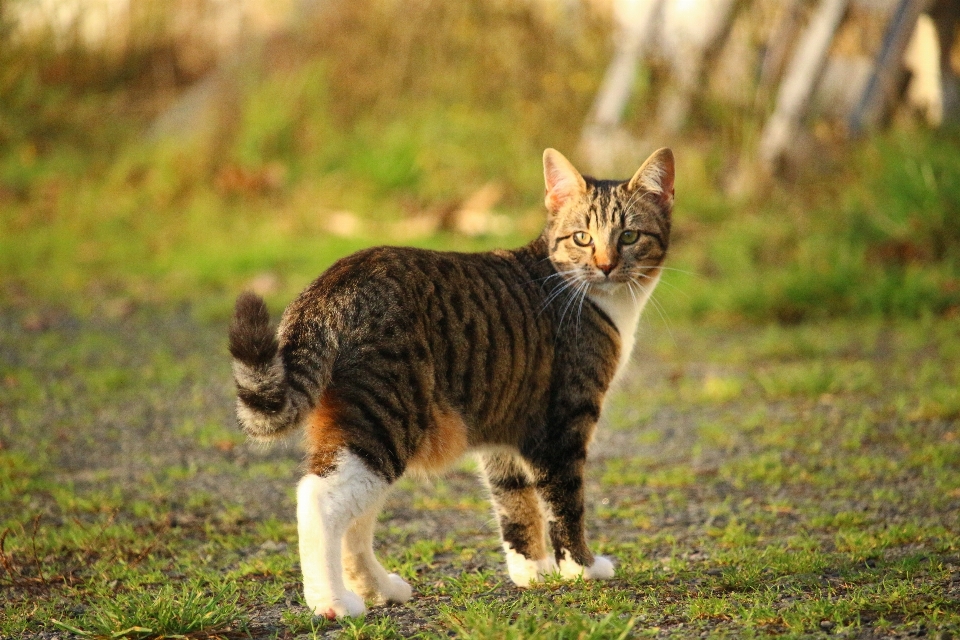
[0,310,960,638]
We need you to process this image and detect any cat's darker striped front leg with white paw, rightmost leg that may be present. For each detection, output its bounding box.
[535,446,614,580]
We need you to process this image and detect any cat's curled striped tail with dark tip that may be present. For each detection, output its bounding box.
[230,291,313,440]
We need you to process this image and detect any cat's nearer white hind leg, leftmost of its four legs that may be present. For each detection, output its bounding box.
[297,448,387,619]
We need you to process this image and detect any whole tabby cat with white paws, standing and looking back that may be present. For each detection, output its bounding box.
[230,149,674,618]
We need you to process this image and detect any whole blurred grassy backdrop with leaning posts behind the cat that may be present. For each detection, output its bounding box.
[0,0,960,326]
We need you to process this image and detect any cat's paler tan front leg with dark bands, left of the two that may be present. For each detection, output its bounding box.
[481,453,557,587]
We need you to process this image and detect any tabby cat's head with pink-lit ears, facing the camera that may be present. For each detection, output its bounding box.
[543,149,674,289]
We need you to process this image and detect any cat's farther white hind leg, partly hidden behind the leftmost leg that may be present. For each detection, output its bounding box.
[343,501,412,604]
